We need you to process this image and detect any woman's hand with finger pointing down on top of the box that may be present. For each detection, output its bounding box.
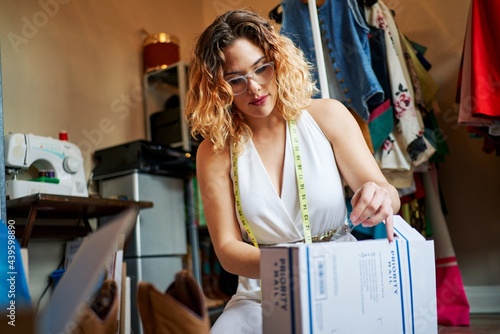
[351,182,394,241]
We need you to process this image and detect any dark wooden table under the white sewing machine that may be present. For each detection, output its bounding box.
[7,193,153,248]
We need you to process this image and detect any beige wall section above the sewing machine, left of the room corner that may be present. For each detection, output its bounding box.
[0,0,202,174]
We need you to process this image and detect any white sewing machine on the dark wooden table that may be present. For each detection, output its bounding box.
[5,133,88,199]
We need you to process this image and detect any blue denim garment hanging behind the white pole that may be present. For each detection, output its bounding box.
[281,0,384,121]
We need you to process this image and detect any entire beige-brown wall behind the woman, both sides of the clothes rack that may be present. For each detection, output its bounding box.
[0,0,500,302]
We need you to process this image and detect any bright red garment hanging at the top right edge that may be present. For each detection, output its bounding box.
[471,0,500,120]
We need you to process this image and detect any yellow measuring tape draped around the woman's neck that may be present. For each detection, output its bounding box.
[232,120,312,248]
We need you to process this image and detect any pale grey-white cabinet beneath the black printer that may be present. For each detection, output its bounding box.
[99,171,187,334]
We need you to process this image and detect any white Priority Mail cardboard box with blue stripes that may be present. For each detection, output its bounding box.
[261,216,438,334]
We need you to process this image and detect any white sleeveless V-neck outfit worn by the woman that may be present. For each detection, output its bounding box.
[228,110,346,306]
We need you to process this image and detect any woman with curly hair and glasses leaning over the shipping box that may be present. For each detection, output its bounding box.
[186,10,400,334]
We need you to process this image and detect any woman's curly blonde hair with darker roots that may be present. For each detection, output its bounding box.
[186,10,316,152]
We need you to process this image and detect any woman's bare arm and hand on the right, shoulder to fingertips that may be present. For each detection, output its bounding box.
[308,99,401,241]
